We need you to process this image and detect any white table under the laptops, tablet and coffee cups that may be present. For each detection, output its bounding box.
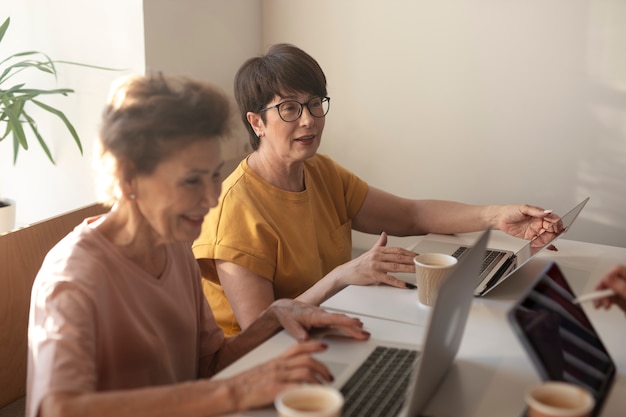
[213,233,626,417]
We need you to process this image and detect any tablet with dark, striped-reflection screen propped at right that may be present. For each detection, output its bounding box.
[508,262,612,416]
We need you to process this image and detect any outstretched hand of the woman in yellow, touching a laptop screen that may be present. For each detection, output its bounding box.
[496,204,564,250]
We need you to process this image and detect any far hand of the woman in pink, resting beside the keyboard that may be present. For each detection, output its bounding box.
[270,299,370,342]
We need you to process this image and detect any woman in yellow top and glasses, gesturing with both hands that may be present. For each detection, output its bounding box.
[193,44,559,335]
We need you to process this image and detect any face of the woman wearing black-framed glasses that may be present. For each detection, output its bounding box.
[248,93,326,164]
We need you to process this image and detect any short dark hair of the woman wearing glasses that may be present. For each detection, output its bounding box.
[230,43,327,150]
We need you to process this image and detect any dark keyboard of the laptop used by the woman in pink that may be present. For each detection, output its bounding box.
[341,346,419,417]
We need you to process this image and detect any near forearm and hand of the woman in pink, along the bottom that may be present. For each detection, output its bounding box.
[38,341,333,417]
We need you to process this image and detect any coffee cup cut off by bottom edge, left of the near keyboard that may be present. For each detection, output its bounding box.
[274,385,343,417]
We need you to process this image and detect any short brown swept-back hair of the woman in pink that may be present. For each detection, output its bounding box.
[99,73,230,202]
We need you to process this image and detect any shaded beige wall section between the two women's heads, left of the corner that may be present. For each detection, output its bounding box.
[144,0,262,162]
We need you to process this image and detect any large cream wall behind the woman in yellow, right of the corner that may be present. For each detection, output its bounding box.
[263,0,626,246]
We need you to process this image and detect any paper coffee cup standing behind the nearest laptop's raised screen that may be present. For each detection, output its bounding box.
[413,253,457,306]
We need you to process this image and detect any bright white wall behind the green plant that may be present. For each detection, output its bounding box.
[0,0,144,226]
